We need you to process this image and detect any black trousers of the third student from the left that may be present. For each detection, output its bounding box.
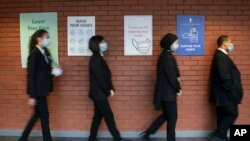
[145,101,177,141]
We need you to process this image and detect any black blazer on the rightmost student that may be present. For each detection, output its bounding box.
[210,50,243,106]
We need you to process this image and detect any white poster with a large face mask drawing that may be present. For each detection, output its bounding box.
[124,16,153,56]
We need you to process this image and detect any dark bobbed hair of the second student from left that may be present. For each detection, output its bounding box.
[89,35,104,53]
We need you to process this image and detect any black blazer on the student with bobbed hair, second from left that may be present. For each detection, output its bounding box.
[89,53,114,100]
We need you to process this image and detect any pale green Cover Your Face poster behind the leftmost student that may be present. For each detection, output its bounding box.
[20,12,59,68]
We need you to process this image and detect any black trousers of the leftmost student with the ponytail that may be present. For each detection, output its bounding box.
[21,97,52,141]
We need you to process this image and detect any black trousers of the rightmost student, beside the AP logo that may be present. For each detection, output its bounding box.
[215,104,238,139]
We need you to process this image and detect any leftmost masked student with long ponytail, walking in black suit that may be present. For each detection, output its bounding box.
[18,30,52,141]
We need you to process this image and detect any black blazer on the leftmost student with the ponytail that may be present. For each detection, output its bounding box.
[27,47,52,98]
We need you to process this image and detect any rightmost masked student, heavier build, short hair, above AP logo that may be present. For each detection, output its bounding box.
[210,35,243,141]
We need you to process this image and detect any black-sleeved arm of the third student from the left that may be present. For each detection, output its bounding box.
[163,55,181,93]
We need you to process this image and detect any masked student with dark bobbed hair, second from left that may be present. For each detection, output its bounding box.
[89,35,130,141]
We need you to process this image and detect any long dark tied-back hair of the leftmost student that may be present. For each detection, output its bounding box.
[29,29,48,53]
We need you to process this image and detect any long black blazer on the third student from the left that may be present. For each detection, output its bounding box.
[153,50,181,109]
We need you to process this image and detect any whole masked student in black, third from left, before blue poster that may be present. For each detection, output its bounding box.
[141,33,182,141]
